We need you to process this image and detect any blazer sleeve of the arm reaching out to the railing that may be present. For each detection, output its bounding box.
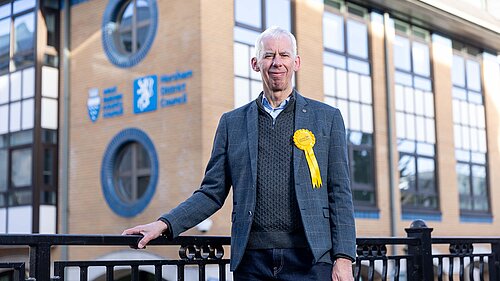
[160,114,231,238]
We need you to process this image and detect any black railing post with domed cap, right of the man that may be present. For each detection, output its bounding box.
[405,220,434,281]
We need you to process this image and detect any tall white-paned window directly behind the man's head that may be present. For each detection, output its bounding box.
[234,0,291,107]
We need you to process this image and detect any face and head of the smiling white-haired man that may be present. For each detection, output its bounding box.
[252,36,300,92]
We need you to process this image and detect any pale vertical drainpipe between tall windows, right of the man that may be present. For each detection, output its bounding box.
[384,13,397,252]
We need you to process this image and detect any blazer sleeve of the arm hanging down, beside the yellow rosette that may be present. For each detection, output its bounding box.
[327,108,356,260]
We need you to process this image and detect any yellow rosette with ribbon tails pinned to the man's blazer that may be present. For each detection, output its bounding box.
[293,129,322,188]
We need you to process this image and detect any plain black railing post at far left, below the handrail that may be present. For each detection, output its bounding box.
[30,243,51,281]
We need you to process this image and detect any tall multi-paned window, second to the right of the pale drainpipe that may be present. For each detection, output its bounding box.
[452,42,490,215]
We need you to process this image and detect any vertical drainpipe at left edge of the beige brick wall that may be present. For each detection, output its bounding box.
[59,0,71,261]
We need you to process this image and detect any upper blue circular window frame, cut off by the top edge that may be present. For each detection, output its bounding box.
[101,0,158,68]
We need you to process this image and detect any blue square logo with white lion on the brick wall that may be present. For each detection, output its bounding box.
[134,75,158,114]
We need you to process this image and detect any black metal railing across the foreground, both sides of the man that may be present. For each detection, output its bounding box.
[0,221,500,281]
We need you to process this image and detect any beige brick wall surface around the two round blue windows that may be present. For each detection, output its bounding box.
[69,1,207,259]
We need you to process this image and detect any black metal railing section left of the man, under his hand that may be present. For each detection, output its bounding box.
[0,234,231,281]
